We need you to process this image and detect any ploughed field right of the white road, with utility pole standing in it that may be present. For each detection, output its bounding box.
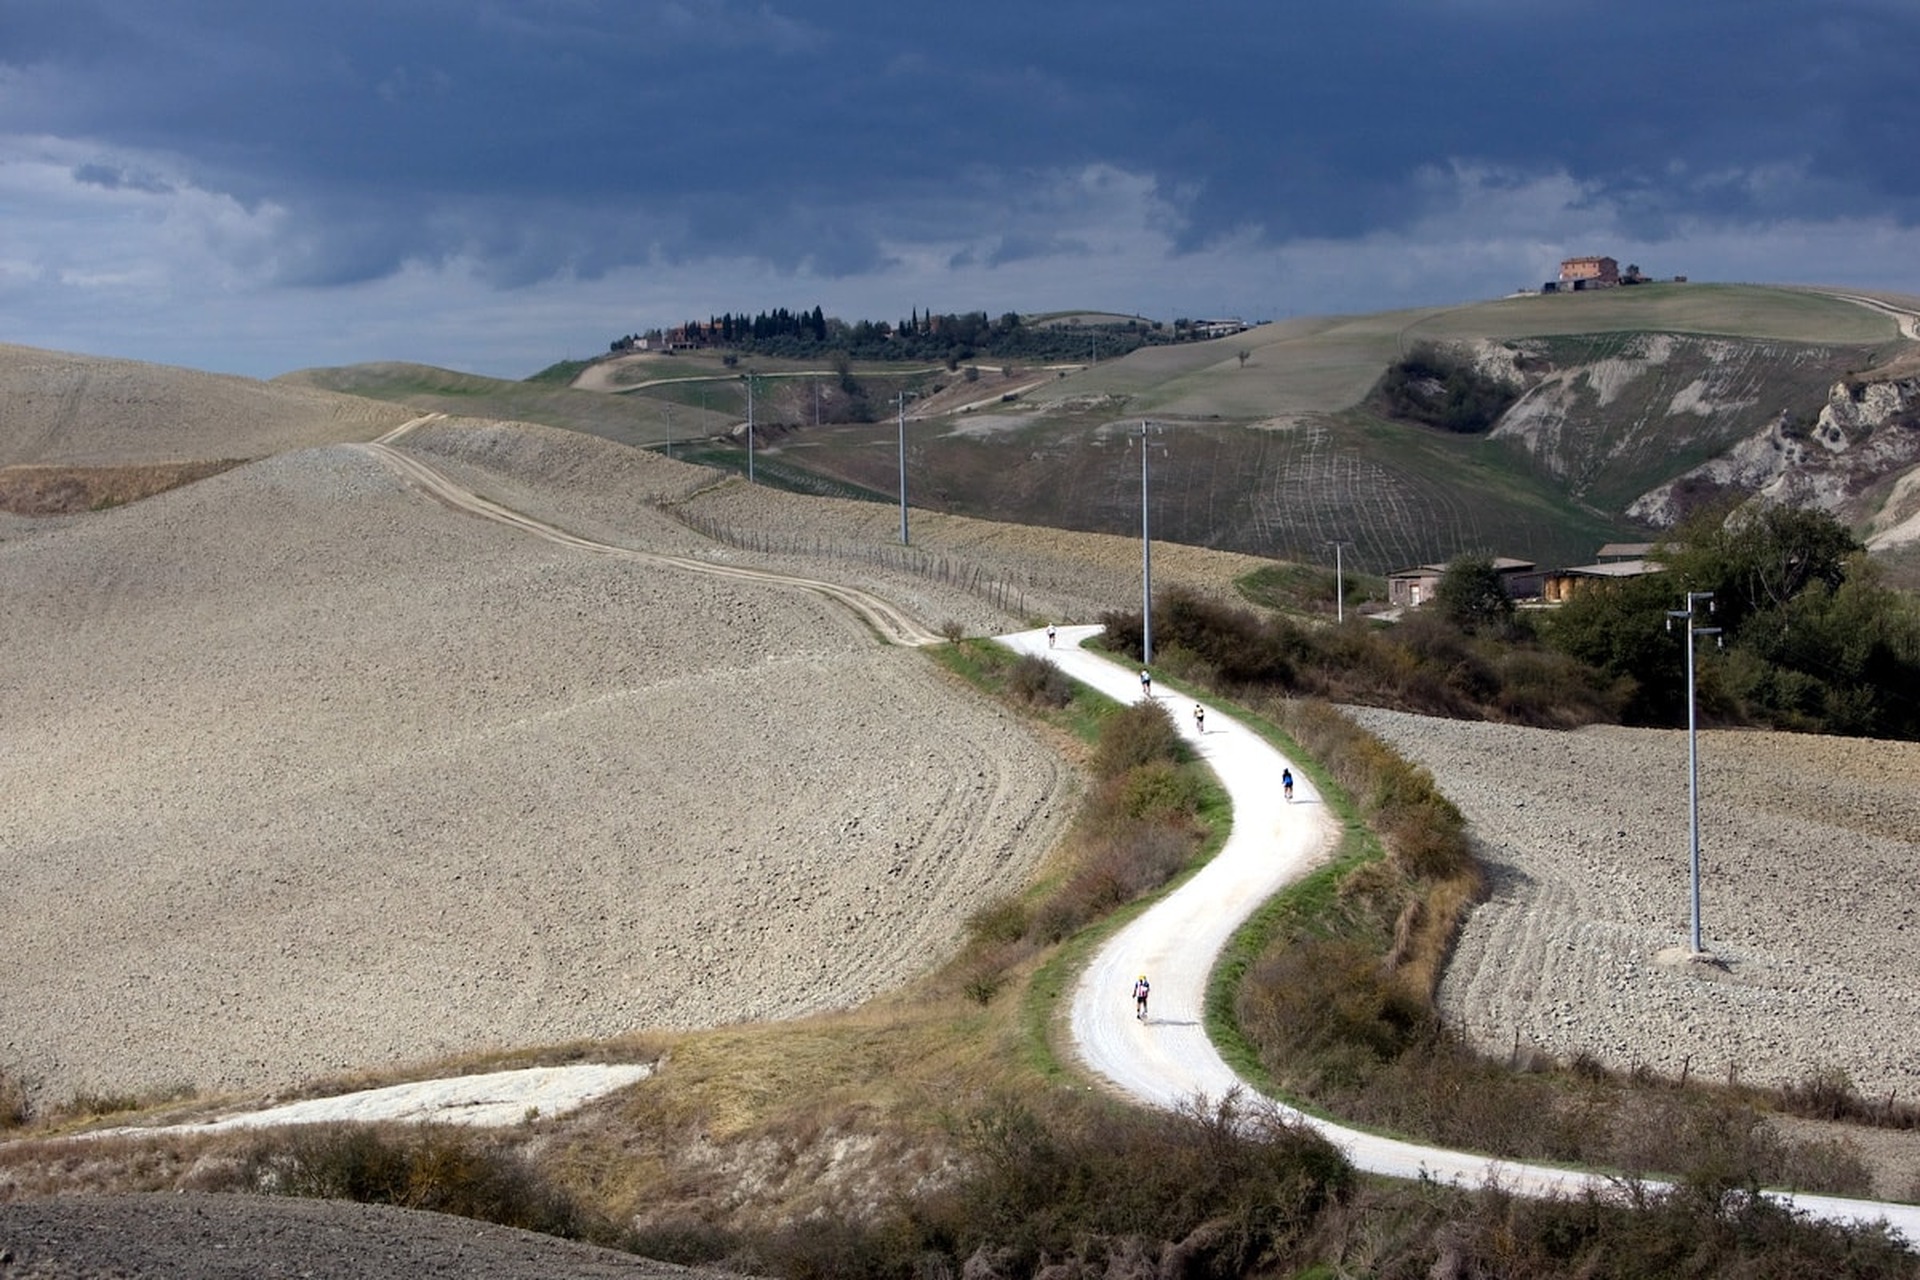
[1352,708,1920,1103]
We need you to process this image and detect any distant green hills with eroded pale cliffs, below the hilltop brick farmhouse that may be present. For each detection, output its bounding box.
[298,284,1920,572]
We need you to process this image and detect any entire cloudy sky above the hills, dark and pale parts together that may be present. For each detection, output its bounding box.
[0,0,1920,376]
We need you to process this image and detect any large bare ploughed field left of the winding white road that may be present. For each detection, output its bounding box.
[0,438,1073,1100]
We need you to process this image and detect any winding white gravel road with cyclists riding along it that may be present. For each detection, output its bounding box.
[1000,626,1920,1247]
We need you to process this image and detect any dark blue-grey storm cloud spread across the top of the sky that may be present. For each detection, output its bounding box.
[15,0,1920,280]
